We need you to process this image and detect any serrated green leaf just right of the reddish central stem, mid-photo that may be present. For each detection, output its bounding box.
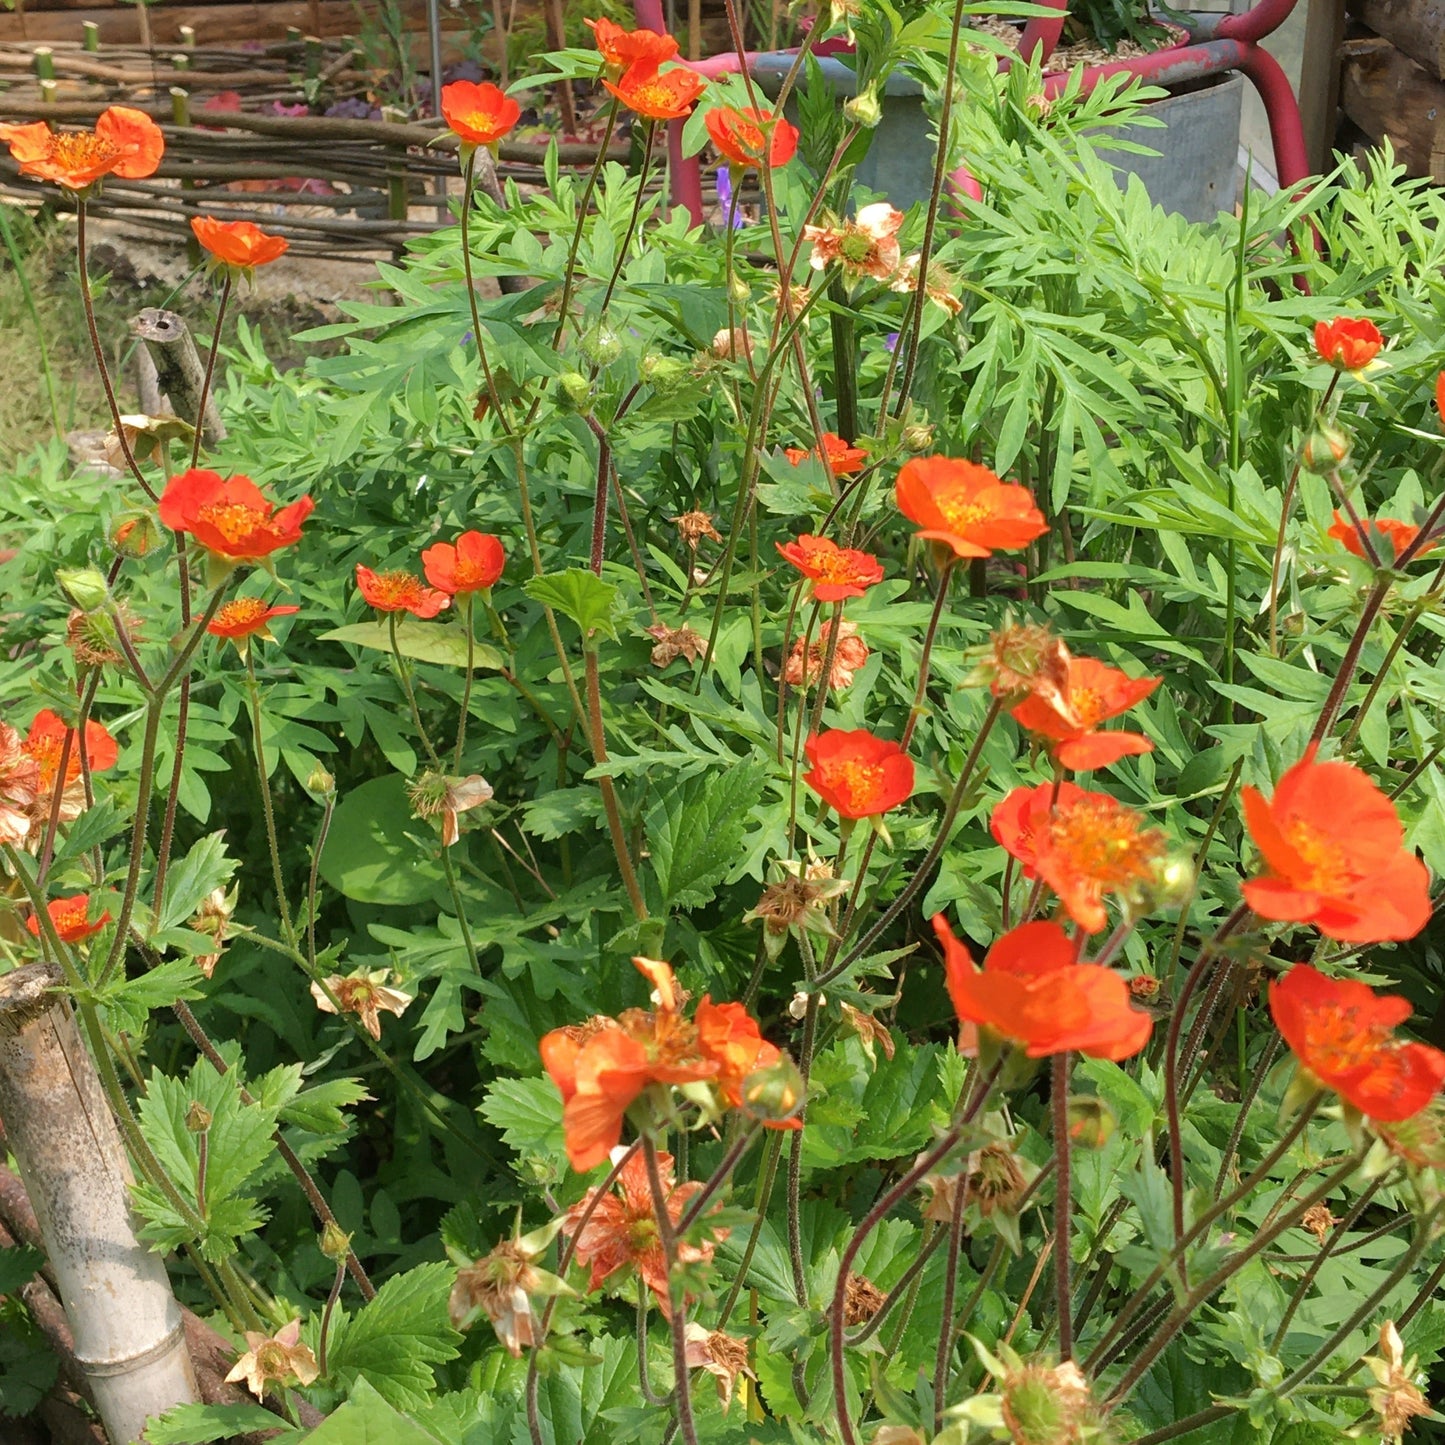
[647,763,766,909]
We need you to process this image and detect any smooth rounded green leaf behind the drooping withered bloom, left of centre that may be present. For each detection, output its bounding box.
[321,775,445,905]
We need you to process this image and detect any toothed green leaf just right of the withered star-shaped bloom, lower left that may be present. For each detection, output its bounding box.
[319,1263,461,1410]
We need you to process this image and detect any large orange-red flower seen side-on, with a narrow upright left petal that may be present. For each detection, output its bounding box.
[933,913,1153,1061]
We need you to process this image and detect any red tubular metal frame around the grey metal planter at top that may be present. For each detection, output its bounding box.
[633,0,1309,224]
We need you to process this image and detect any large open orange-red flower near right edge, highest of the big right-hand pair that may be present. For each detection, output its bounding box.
[1241,744,1431,944]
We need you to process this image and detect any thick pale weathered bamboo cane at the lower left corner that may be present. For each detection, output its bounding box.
[0,964,198,1445]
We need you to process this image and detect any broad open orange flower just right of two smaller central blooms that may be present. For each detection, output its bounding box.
[893,457,1049,558]
